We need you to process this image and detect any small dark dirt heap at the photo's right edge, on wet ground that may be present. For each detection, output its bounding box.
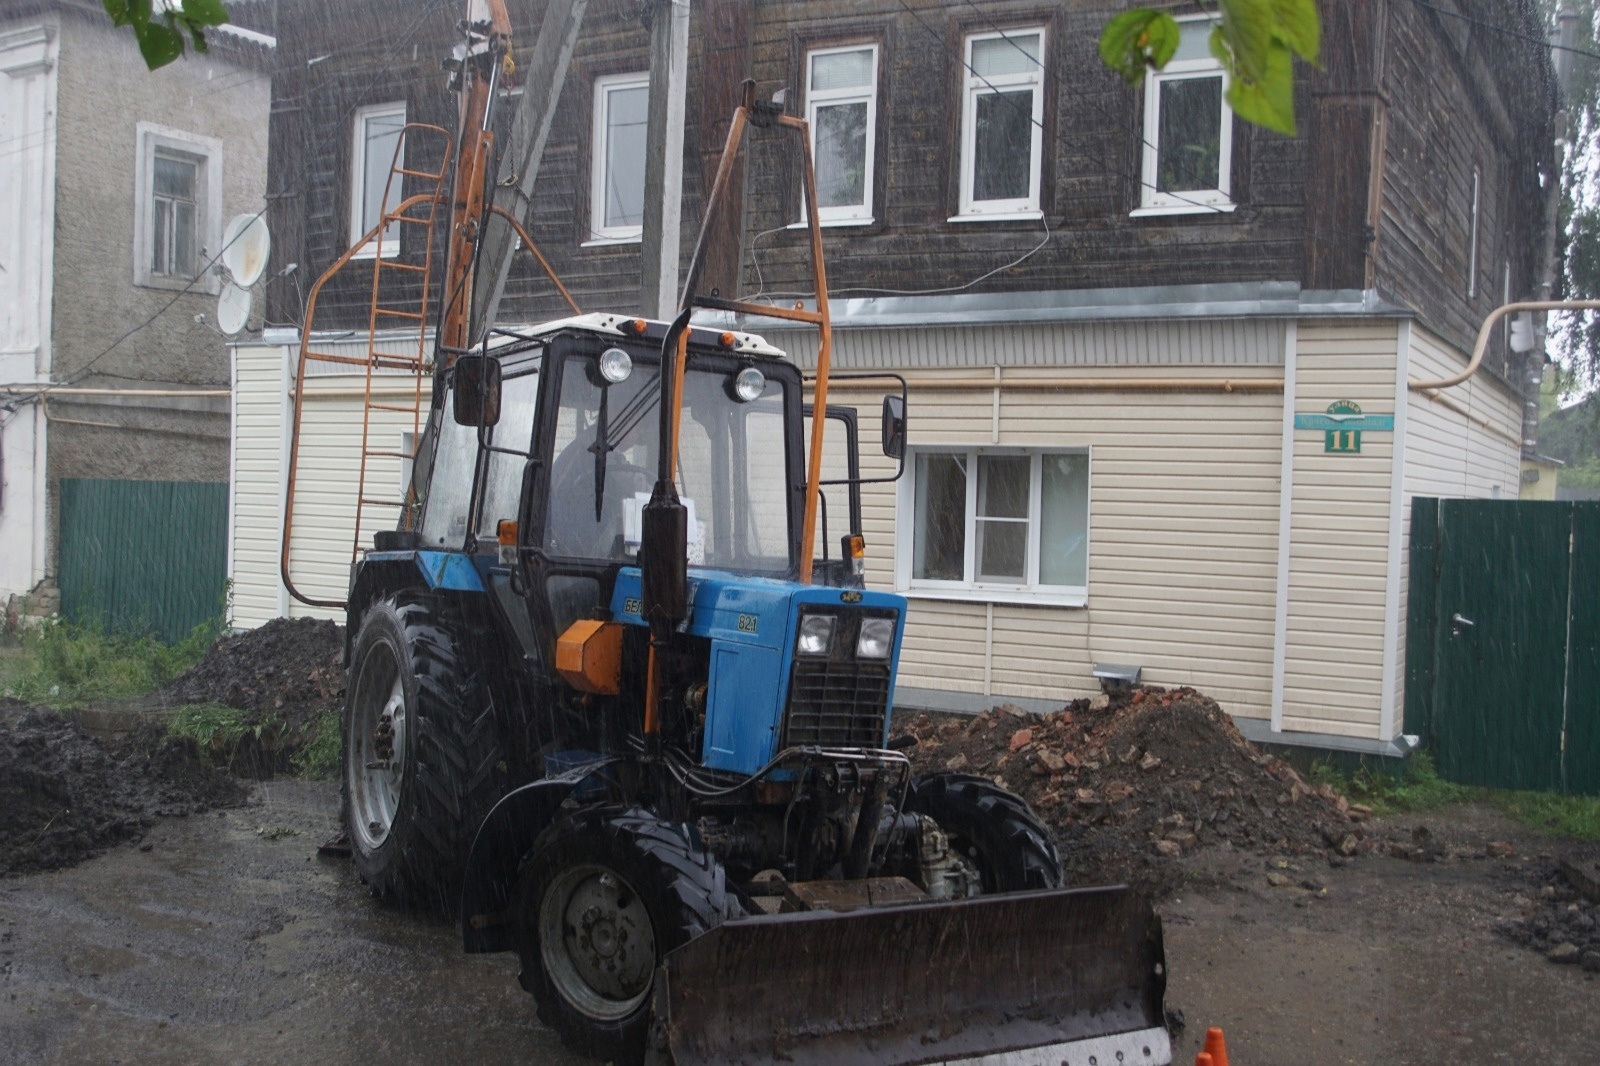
[1496,847,1600,973]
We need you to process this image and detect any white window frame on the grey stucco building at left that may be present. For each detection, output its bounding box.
[133,122,222,295]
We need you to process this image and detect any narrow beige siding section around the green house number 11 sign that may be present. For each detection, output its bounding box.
[1280,320,1400,729]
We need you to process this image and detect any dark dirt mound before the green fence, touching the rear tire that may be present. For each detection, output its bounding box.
[160,618,344,725]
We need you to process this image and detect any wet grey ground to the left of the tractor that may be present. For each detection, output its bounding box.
[0,781,584,1066]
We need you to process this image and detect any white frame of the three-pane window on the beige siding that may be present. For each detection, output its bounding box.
[894,445,1094,607]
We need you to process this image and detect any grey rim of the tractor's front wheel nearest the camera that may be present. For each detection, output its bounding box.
[539,866,656,1021]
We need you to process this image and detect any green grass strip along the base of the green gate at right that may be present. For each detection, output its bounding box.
[1310,752,1600,840]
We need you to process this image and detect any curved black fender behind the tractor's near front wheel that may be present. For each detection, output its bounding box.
[461,757,616,954]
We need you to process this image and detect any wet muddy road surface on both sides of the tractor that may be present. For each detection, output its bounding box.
[0,779,1600,1066]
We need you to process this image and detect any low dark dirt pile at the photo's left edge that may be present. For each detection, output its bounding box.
[0,707,246,876]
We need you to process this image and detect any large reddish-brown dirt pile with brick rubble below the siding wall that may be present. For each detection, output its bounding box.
[898,687,1371,895]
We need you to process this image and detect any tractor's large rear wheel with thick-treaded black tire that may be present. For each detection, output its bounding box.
[342,597,506,916]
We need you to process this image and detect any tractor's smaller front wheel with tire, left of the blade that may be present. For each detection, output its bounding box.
[517,808,742,1066]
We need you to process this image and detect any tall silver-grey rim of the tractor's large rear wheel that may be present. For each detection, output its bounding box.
[346,643,410,852]
